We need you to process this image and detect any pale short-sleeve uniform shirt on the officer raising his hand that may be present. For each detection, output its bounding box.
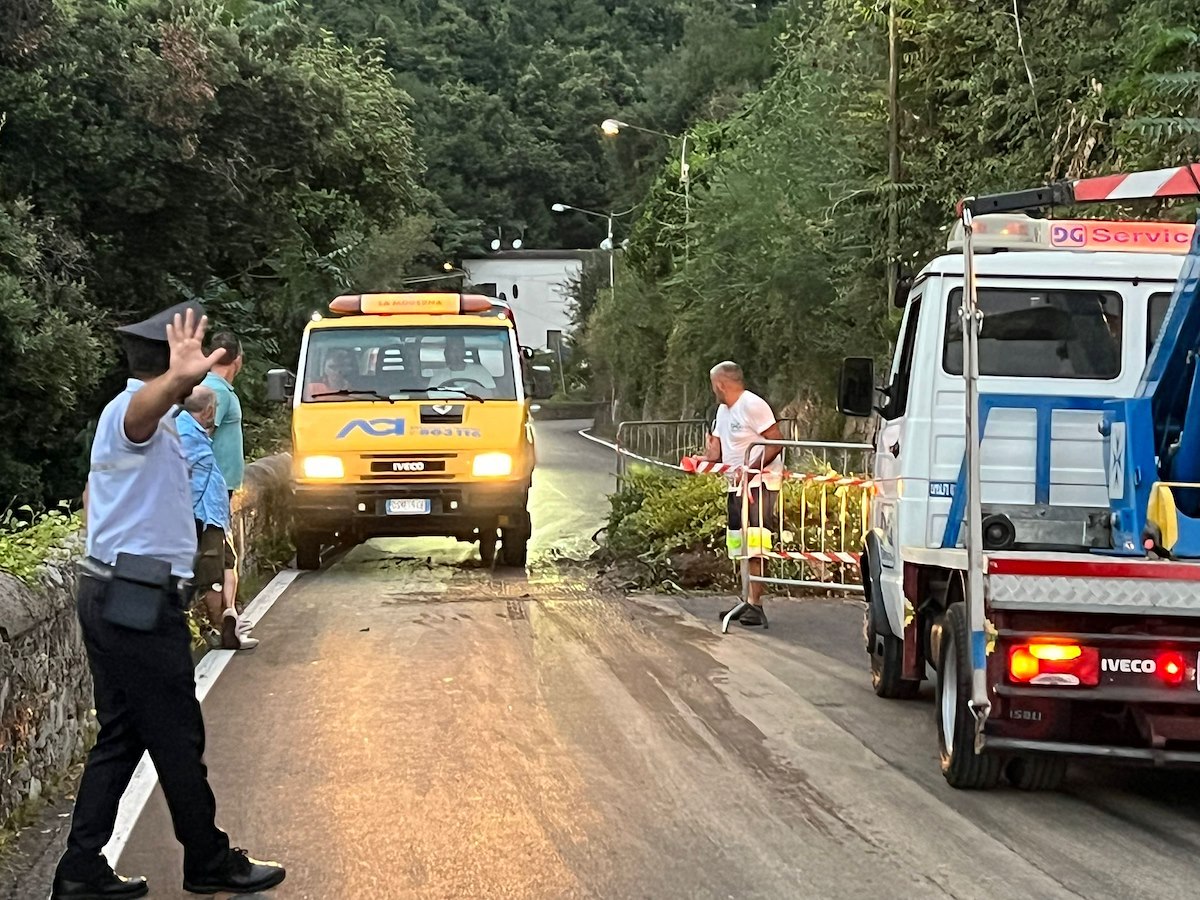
[88,379,196,578]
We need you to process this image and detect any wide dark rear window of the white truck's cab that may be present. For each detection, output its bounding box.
[942,288,1122,379]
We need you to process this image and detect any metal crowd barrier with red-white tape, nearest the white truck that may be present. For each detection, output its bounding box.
[721,440,875,631]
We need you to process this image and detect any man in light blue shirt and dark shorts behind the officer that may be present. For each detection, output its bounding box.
[176,384,258,650]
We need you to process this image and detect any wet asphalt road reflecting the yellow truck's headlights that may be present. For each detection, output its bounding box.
[112,422,1200,899]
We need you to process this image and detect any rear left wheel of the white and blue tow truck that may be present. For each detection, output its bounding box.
[936,602,1001,791]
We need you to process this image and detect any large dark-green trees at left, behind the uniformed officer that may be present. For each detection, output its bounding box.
[0,0,422,502]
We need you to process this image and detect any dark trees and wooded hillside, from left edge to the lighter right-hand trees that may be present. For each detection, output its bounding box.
[0,0,772,506]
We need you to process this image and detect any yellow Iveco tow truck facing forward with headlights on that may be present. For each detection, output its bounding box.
[268,293,546,569]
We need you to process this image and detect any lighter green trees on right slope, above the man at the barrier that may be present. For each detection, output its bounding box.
[583,0,1200,430]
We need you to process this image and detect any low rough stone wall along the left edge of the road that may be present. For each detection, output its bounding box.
[0,455,290,826]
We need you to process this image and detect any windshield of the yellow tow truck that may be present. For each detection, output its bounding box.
[301,326,517,403]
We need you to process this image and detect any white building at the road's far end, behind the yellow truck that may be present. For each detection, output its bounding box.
[462,250,595,349]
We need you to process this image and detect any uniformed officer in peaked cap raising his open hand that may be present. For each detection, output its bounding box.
[50,304,284,900]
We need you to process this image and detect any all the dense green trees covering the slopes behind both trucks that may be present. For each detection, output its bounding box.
[0,0,1200,504]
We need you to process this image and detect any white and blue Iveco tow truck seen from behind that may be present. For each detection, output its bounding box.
[839,164,1200,790]
